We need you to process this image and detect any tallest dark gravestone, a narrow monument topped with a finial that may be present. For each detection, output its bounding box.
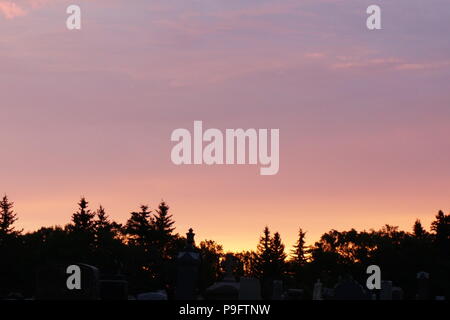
[175,228,200,300]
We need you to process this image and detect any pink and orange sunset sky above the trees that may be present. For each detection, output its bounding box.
[0,0,450,250]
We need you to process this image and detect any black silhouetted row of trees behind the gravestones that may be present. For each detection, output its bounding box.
[0,195,450,299]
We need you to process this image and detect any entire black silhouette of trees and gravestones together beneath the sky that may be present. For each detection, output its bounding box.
[0,196,450,300]
